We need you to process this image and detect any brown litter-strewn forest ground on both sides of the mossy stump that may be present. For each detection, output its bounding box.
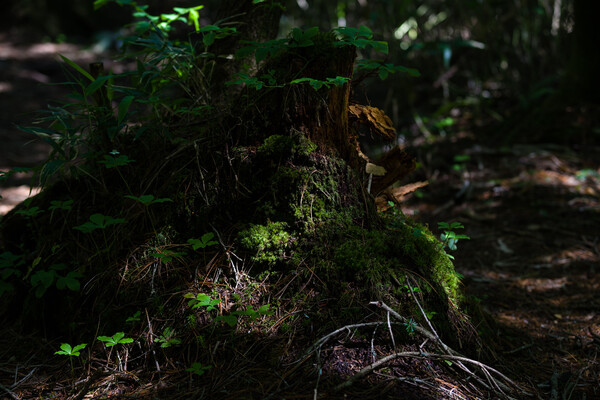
[0,32,600,400]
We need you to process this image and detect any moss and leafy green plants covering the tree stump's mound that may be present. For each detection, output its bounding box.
[0,0,496,393]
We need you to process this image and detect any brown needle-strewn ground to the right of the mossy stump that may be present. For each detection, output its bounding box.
[405,139,600,399]
